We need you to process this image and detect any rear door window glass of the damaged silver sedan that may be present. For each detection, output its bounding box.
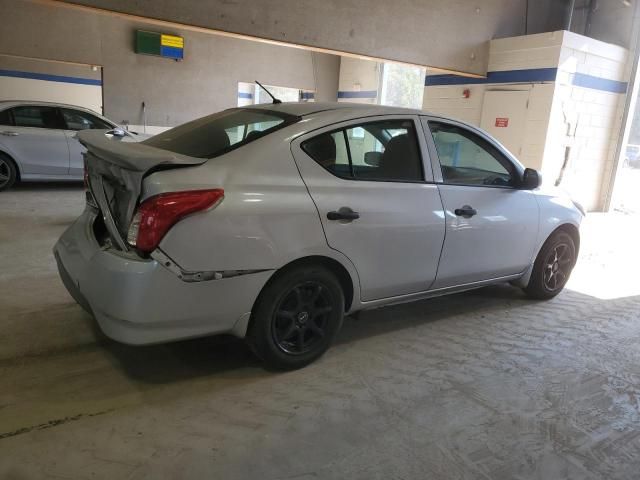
[302,120,424,182]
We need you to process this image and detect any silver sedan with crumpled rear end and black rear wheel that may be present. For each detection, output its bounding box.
[54,103,584,368]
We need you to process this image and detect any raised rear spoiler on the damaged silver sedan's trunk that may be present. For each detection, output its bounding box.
[77,130,207,172]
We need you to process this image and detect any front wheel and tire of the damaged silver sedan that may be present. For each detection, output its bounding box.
[524,231,576,300]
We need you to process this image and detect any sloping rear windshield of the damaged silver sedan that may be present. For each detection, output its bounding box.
[142,108,299,158]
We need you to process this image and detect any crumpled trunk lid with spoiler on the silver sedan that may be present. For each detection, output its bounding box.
[78,130,207,251]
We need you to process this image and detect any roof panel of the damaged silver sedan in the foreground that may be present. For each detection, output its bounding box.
[244,102,425,117]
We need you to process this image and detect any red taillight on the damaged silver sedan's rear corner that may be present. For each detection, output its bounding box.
[127,188,224,252]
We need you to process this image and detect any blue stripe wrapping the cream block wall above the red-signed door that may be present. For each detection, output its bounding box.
[424,68,628,93]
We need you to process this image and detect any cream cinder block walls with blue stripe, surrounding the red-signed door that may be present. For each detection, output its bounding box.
[423,31,630,210]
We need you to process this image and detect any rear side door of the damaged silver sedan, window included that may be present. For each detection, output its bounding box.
[292,116,445,301]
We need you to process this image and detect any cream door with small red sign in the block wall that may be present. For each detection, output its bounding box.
[480,90,529,157]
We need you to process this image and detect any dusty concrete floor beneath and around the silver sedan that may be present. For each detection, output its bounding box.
[0,185,640,480]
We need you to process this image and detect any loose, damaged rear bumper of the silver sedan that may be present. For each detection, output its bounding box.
[54,207,273,344]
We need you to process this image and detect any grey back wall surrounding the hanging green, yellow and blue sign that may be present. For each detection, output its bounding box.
[0,0,339,127]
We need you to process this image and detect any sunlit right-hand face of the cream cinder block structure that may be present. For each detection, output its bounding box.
[544,32,631,210]
